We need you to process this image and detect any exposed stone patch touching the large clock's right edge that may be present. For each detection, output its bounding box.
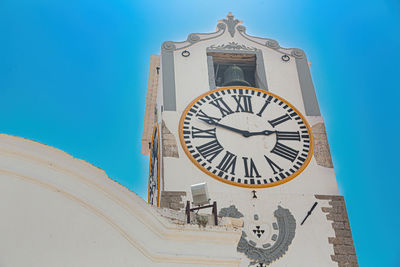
[311,122,333,168]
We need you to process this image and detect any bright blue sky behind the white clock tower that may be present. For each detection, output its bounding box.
[0,0,400,267]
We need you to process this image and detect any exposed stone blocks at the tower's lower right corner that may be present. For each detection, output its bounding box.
[315,195,358,267]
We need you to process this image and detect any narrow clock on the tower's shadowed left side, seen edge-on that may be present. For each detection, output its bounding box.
[148,124,160,207]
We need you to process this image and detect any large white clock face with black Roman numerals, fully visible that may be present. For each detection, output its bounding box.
[179,86,314,188]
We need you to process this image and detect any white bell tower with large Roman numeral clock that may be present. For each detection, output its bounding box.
[142,13,358,267]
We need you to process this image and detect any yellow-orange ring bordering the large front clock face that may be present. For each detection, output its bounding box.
[179,86,314,188]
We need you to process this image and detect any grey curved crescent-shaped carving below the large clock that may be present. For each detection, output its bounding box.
[237,206,296,266]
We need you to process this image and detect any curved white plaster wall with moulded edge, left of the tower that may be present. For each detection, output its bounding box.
[0,134,240,267]
